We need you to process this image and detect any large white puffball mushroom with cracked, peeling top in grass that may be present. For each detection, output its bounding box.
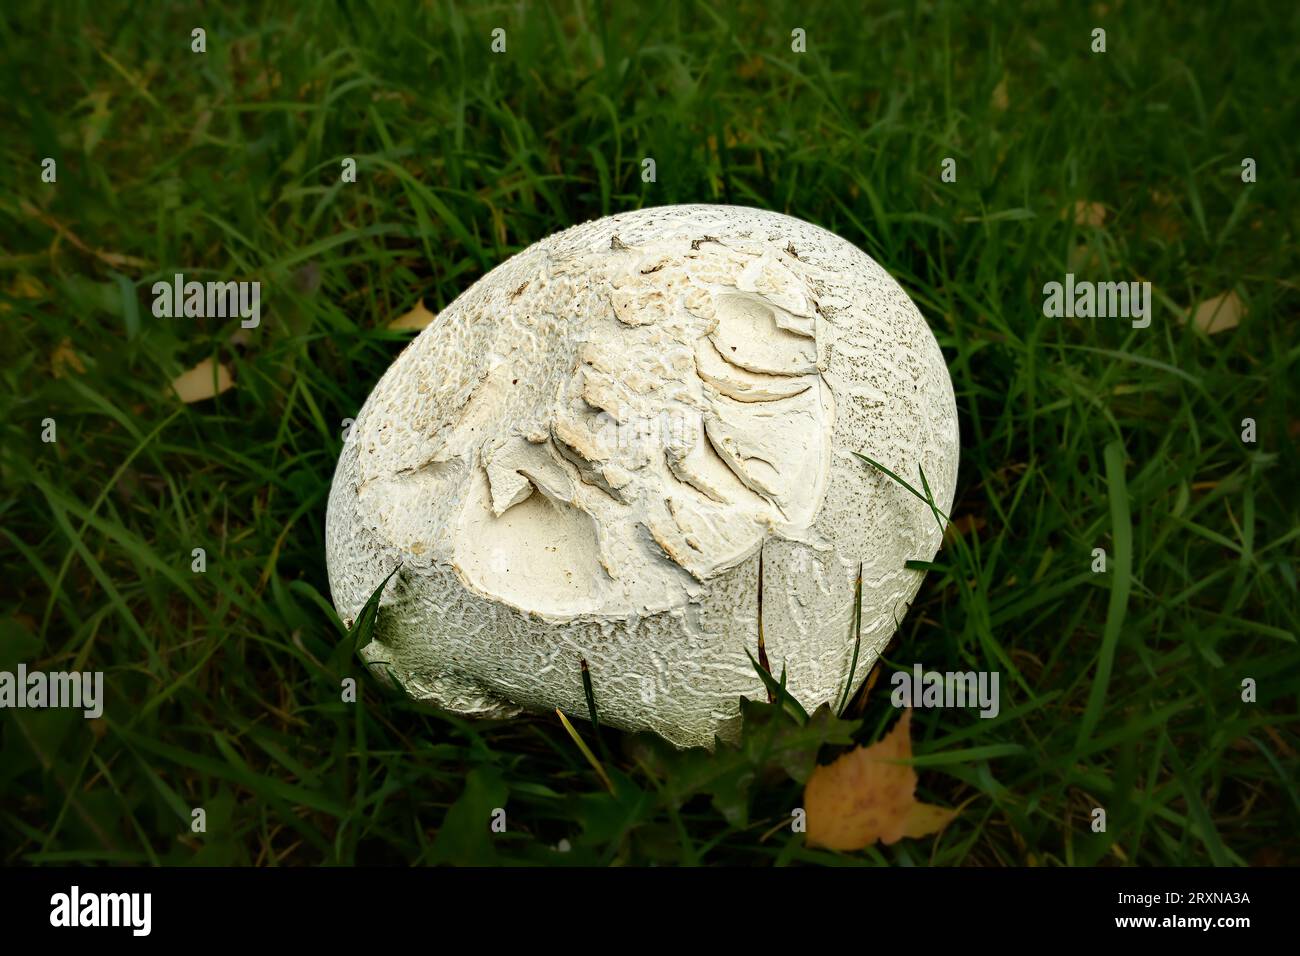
[326,206,958,747]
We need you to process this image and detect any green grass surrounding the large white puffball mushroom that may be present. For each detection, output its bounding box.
[0,0,1300,865]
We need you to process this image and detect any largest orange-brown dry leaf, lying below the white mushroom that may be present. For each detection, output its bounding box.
[803,709,957,851]
